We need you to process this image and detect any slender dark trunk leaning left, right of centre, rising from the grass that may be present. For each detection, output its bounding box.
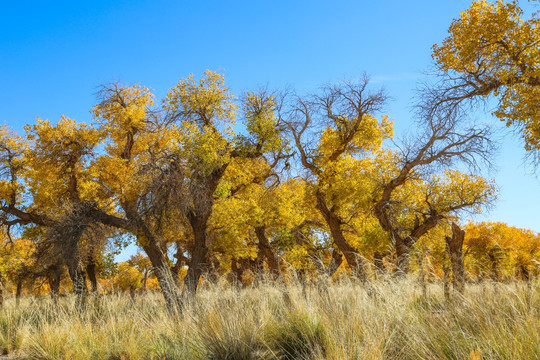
[317,192,367,281]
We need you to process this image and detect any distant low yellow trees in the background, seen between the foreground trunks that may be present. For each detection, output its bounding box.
[0,222,540,299]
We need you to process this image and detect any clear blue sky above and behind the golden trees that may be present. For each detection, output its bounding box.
[0,0,540,243]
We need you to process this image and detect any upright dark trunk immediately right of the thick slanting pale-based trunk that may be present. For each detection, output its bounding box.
[186,213,209,296]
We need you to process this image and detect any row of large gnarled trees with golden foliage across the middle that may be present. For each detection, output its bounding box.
[0,2,538,313]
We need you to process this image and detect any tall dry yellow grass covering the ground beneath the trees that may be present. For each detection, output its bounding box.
[0,280,540,360]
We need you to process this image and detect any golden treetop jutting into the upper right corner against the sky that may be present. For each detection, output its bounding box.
[433,0,540,150]
